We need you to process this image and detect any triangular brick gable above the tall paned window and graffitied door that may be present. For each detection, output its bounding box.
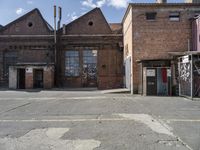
[65,8,112,34]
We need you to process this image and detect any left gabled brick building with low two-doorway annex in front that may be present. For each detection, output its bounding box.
[0,9,54,89]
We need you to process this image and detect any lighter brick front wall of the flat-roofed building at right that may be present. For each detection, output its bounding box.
[123,4,200,93]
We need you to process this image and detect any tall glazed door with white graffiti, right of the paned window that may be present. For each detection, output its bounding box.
[82,50,97,87]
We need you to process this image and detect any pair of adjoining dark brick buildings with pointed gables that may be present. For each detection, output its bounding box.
[0,8,123,89]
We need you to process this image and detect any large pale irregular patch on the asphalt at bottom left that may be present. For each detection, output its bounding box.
[0,128,101,150]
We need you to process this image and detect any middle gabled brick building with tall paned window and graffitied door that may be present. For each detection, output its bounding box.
[56,8,123,89]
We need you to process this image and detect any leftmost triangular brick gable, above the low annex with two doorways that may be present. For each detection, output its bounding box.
[0,9,52,35]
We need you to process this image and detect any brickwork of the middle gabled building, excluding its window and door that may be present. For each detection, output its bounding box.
[56,8,123,89]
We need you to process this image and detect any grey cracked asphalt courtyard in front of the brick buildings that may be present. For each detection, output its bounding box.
[0,90,200,150]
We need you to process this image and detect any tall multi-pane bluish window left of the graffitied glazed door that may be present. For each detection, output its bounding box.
[65,51,80,77]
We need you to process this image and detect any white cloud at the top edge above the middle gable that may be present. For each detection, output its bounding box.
[81,0,132,8]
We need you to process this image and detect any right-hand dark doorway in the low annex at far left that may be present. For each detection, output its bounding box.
[33,69,43,88]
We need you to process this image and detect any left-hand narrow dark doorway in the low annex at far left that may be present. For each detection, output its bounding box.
[17,69,25,89]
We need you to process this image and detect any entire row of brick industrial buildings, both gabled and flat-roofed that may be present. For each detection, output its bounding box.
[0,0,200,96]
